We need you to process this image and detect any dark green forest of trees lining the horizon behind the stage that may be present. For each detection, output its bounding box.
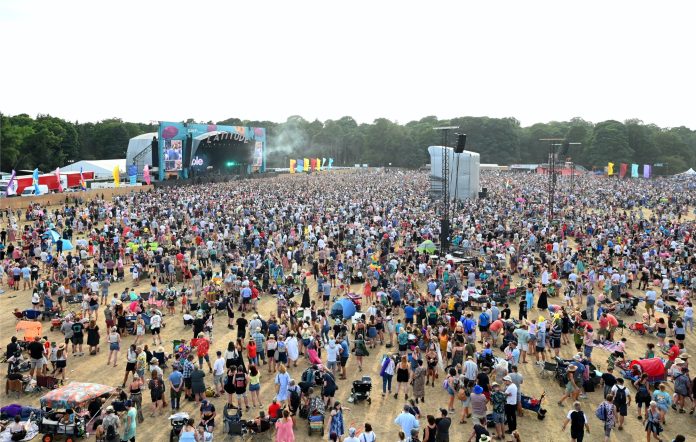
[0,114,696,174]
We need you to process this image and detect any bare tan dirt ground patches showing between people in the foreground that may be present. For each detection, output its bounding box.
[0,212,696,442]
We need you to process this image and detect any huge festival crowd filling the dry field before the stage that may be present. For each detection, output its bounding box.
[0,171,696,442]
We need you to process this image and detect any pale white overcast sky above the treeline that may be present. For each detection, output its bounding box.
[0,0,696,128]
